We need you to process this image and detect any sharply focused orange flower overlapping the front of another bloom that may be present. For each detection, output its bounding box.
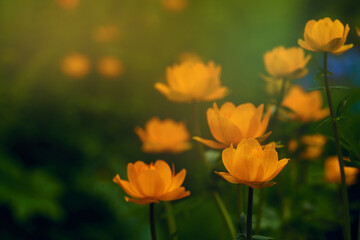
[215,139,289,188]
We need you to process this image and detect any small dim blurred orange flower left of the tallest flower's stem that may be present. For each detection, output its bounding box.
[300,134,327,159]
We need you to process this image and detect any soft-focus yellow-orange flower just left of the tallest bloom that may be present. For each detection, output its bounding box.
[264,46,311,79]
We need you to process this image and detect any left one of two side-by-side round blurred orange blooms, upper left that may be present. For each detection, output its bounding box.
[61,53,90,78]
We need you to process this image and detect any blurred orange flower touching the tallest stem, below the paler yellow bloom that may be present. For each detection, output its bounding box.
[282,85,329,123]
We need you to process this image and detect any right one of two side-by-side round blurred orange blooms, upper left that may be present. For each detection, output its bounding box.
[97,57,124,78]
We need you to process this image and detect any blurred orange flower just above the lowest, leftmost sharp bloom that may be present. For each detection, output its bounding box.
[135,117,191,153]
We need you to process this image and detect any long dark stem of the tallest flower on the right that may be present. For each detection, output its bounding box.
[324,52,351,240]
